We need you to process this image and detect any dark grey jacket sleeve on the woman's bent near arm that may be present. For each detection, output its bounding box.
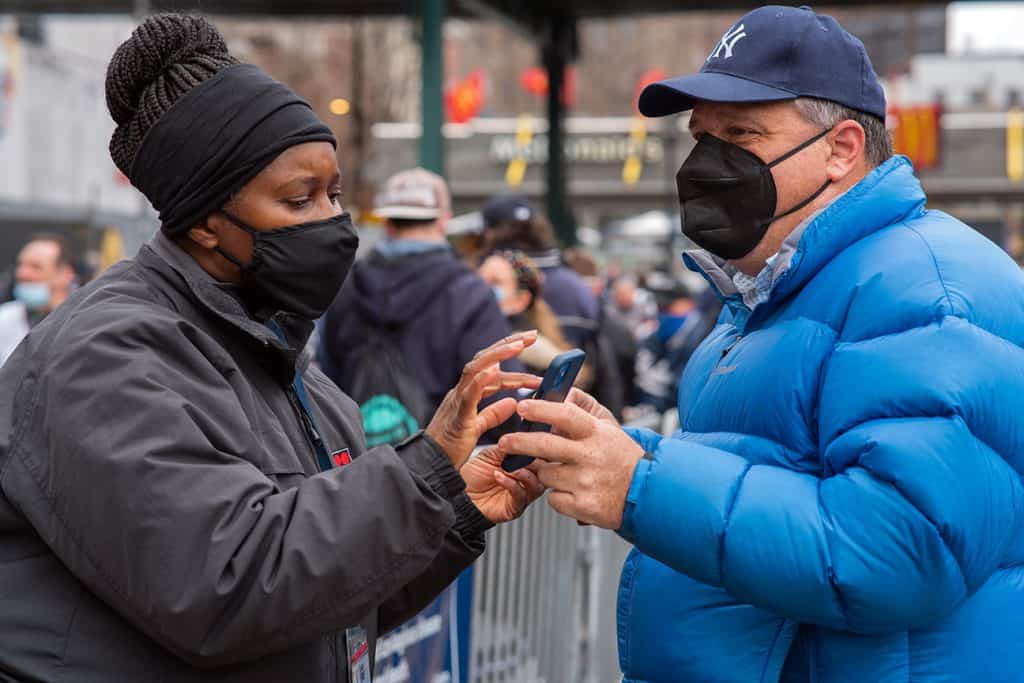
[0,317,482,667]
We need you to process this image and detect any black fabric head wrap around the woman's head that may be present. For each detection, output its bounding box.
[128,65,337,236]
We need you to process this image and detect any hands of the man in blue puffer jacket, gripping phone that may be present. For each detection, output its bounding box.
[498,389,644,530]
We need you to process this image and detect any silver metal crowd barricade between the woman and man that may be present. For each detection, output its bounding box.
[467,413,678,683]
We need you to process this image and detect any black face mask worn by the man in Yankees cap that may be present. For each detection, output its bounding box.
[676,129,831,260]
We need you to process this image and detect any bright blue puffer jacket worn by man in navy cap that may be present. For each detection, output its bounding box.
[618,158,1024,683]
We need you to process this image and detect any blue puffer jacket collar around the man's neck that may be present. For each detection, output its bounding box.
[683,157,926,325]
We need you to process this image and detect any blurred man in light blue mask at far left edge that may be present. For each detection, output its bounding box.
[0,233,75,365]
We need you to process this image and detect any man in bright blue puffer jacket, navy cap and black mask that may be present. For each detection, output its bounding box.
[502,7,1024,683]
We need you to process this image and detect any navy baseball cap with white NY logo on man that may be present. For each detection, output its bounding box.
[639,5,886,121]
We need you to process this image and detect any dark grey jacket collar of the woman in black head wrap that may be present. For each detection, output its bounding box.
[139,231,313,381]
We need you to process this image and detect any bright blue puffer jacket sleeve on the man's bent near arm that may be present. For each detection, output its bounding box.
[621,316,1024,633]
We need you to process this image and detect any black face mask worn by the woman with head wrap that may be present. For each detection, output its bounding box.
[216,210,359,321]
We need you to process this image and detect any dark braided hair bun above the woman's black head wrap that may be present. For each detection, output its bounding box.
[106,14,239,175]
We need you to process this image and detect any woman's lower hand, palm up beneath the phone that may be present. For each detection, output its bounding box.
[459,447,544,524]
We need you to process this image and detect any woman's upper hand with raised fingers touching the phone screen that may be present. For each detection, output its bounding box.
[424,330,541,469]
